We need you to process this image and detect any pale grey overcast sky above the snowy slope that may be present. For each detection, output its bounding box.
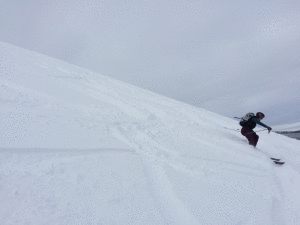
[0,0,300,122]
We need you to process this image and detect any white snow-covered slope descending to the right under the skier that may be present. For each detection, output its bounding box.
[0,42,300,225]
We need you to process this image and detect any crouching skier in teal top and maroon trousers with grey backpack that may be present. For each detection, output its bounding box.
[240,112,272,147]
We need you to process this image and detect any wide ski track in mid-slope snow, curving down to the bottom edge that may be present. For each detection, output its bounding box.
[114,123,203,225]
